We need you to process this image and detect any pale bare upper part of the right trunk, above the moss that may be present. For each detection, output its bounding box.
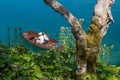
[93,0,114,37]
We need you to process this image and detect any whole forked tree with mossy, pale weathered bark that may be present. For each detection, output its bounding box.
[44,0,114,80]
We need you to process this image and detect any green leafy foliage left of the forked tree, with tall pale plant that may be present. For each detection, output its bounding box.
[0,26,76,80]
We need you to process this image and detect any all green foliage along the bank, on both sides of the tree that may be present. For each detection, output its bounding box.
[0,27,120,80]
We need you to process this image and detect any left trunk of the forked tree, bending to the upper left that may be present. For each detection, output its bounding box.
[44,0,87,78]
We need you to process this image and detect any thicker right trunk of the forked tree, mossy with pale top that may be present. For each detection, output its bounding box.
[87,0,114,74]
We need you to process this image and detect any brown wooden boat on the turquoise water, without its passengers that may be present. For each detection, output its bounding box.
[22,31,58,49]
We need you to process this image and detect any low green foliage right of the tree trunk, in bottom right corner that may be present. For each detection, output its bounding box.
[97,60,120,80]
